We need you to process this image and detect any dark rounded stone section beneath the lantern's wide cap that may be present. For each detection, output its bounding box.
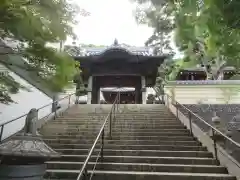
[0,164,46,180]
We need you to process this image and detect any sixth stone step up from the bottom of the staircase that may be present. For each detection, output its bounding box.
[44,139,201,146]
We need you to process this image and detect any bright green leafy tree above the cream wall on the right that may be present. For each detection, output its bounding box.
[175,0,240,79]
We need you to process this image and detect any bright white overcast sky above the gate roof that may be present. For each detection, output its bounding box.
[67,0,152,46]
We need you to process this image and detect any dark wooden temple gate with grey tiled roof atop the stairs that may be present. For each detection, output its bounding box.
[74,40,166,104]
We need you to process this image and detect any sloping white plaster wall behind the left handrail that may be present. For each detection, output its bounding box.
[0,64,76,139]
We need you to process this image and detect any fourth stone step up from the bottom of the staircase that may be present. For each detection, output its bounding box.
[54,148,213,158]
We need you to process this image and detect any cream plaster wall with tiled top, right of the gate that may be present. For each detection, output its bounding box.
[165,85,240,104]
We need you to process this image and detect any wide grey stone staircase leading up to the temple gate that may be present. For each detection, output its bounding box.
[41,105,236,180]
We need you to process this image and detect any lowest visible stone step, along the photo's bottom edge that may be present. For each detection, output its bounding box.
[46,169,236,180]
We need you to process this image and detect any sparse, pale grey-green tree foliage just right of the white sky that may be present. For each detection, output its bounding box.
[135,0,174,55]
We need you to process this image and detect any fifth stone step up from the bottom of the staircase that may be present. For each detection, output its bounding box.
[47,143,207,151]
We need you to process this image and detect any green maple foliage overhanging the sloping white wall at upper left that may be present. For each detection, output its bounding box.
[0,0,87,103]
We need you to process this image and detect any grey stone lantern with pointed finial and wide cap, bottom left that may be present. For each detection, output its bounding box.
[0,109,60,180]
